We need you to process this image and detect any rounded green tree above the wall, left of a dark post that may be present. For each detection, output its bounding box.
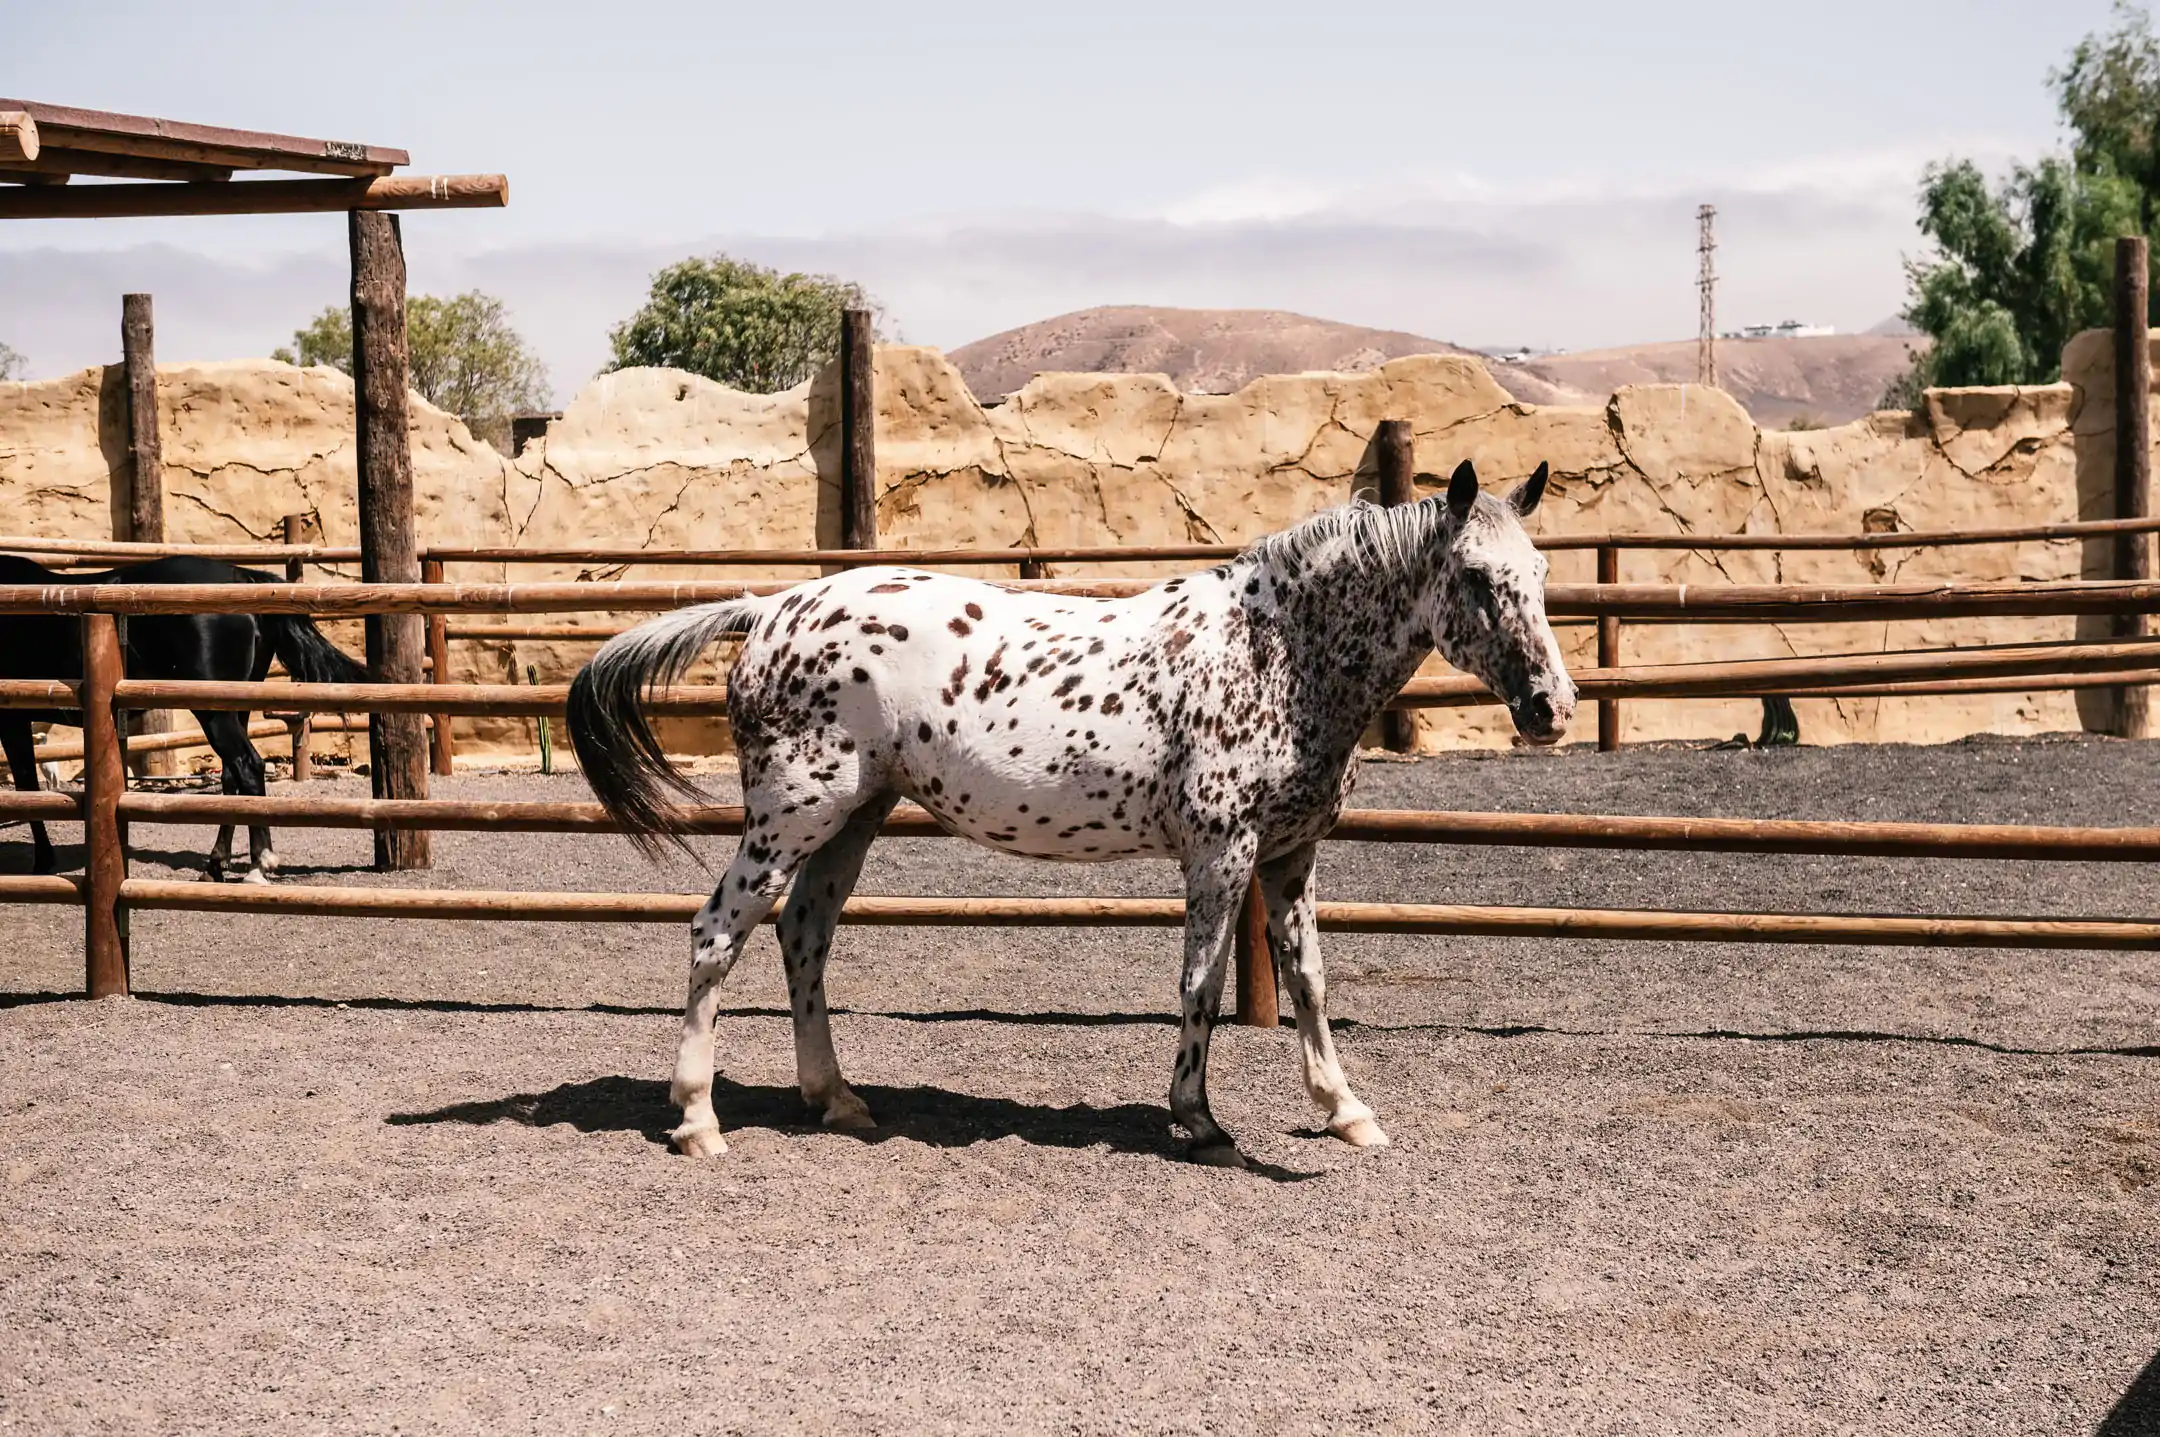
[607,255,875,393]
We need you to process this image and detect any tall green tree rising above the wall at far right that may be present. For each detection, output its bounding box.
[1886,0,2160,402]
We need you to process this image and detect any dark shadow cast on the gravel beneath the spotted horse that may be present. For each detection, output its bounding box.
[384,1074,1320,1182]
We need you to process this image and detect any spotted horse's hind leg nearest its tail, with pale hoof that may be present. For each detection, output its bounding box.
[667,790,847,1158]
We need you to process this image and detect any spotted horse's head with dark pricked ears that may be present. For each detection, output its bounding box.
[1419,460,1575,743]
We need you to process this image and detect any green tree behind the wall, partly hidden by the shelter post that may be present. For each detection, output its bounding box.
[270,290,546,449]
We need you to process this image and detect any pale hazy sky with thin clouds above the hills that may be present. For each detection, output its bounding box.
[0,0,2108,395]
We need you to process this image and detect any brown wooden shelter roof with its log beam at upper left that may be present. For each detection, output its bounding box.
[0,99,510,218]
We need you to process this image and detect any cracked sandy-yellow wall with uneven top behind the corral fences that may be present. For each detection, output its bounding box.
[0,335,2112,748]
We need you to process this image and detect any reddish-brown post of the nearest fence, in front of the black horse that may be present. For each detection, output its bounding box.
[82,614,127,998]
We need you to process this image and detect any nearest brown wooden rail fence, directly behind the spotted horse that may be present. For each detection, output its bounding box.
[0,581,2160,1024]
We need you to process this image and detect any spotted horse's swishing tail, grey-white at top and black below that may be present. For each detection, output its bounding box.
[570,599,762,858]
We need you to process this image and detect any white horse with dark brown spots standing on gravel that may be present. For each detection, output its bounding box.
[570,462,1575,1167]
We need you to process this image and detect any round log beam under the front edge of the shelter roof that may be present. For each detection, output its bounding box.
[0,175,510,220]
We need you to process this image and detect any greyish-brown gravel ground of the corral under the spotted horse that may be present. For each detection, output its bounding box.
[0,739,2160,1435]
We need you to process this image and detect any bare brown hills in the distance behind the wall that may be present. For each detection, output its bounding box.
[950,305,1916,428]
